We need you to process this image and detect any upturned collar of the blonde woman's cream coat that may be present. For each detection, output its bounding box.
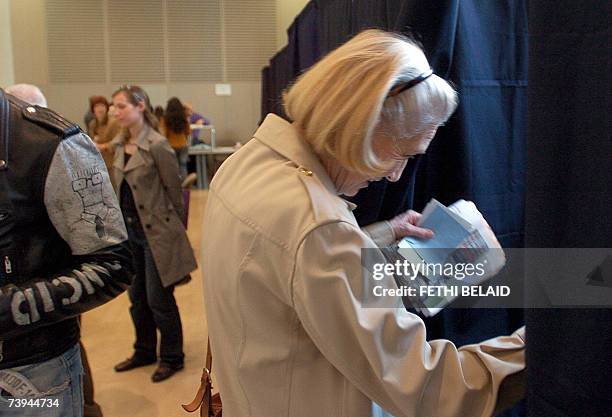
[253,114,344,200]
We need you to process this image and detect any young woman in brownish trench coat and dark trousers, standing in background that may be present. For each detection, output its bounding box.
[113,86,196,382]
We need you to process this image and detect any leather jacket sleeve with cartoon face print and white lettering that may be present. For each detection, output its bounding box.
[0,134,133,339]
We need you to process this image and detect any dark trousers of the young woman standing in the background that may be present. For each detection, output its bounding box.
[125,216,185,366]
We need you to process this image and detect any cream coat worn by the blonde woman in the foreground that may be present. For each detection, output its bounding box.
[202,115,525,417]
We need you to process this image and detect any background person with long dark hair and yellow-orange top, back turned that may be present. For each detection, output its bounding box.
[160,97,191,179]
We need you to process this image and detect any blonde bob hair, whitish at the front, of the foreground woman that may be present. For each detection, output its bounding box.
[283,29,457,177]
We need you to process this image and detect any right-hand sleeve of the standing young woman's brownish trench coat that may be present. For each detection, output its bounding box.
[151,140,185,219]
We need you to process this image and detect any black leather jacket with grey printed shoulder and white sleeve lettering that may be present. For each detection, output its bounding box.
[0,90,133,369]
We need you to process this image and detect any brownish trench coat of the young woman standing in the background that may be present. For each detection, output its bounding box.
[113,125,197,287]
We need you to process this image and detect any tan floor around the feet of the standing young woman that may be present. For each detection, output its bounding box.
[82,190,207,417]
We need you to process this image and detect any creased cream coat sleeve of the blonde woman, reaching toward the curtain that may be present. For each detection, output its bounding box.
[292,222,525,417]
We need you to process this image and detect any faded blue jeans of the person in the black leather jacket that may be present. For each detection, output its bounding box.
[0,344,83,417]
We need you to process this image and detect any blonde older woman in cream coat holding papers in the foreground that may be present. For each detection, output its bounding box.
[202,30,525,417]
